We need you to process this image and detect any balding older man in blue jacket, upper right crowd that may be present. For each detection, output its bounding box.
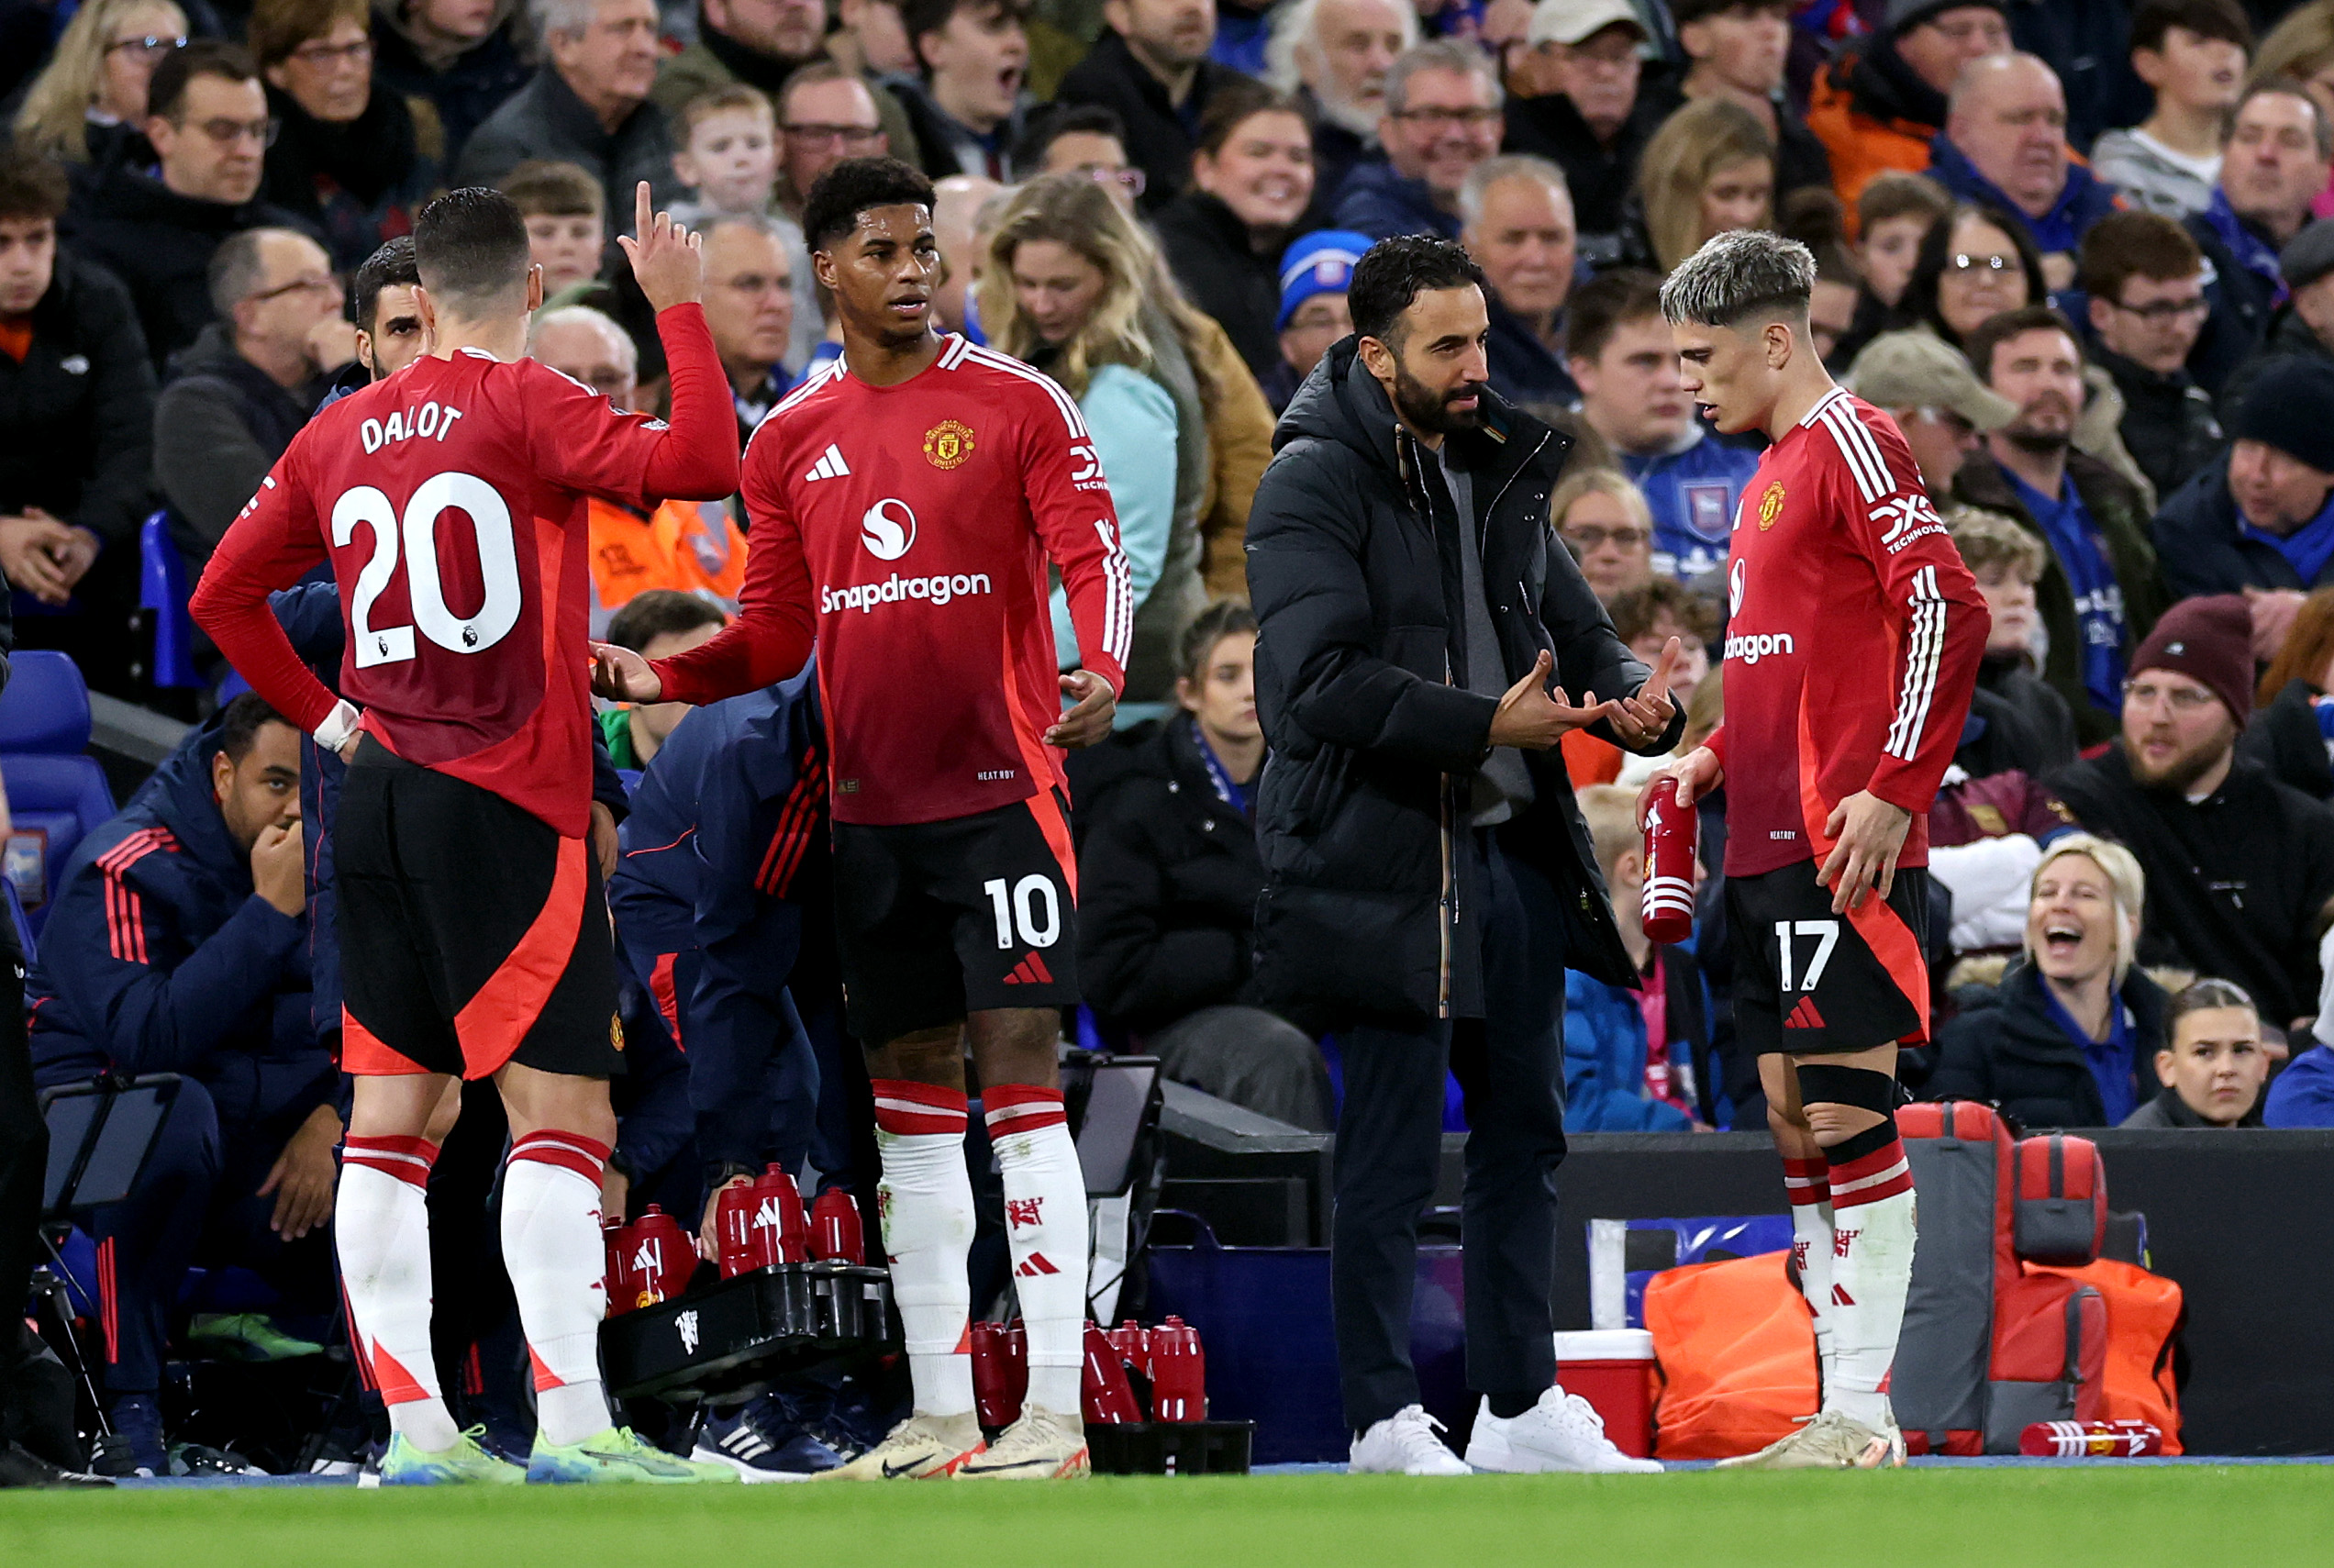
[1928,53,2124,289]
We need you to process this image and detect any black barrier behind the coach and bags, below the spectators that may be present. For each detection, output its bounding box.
[1167,1106,2334,1453]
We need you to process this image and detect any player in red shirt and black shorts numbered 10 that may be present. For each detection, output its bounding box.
[600,159,1134,1479]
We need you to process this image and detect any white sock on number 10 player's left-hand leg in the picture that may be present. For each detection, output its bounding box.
[872,1078,973,1417]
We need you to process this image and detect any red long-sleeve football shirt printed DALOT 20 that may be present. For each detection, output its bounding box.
[192,304,738,838]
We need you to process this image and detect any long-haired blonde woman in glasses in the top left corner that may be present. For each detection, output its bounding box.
[14,0,187,163]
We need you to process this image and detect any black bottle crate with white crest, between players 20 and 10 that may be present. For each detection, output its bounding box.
[600,1262,892,1400]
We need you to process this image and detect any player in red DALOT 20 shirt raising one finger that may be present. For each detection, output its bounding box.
[194,184,738,1484]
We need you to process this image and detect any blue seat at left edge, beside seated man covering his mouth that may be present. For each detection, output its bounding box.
[0,649,115,936]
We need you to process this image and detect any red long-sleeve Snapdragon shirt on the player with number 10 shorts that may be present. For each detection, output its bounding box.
[653,336,1134,824]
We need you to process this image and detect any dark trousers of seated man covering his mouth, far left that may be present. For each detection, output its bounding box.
[89,1078,334,1393]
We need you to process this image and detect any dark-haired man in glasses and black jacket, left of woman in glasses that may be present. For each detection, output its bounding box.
[63,39,322,366]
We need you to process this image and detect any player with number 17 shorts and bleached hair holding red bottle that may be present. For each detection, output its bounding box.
[1662,228,1986,1470]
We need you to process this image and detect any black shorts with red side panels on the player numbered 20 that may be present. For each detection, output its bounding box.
[334,735,623,1078]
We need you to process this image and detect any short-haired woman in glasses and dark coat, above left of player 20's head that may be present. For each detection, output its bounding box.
[250,0,437,268]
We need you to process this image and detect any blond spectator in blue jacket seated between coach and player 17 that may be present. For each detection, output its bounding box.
[1563,784,1729,1131]
